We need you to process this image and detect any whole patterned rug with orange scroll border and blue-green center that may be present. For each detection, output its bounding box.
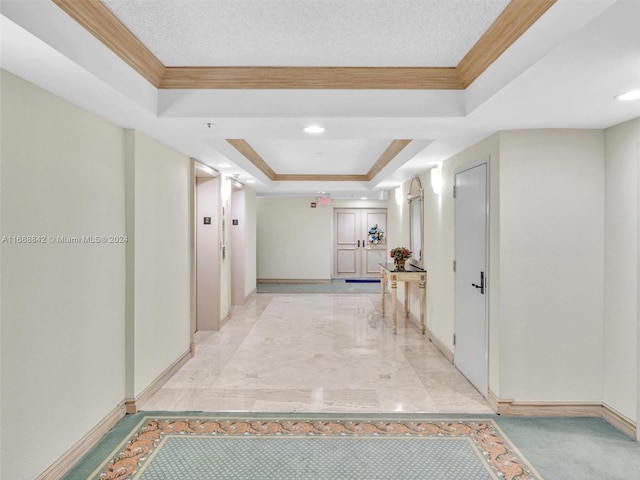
[89,415,542,480]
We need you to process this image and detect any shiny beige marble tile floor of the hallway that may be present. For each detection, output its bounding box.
[142,294,492,413]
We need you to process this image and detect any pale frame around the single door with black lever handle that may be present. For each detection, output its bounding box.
[452,155,491,398]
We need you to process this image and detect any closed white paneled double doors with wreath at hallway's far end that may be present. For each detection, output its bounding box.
[333,208,387,278]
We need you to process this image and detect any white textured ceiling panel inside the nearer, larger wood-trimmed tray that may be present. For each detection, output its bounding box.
[102,0,509,67]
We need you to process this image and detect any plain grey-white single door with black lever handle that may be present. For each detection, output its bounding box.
[454,163,488,396]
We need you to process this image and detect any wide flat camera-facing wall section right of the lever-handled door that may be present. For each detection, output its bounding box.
[499,130,604,402]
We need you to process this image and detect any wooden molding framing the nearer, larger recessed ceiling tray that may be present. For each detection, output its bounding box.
[53,0,556,90]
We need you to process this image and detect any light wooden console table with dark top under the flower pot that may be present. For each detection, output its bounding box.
[380,263,427,335]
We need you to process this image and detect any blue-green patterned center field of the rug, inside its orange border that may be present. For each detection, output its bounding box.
[139,435,495,480]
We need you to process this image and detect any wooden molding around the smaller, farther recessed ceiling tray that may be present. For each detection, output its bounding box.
[226,138,411,182]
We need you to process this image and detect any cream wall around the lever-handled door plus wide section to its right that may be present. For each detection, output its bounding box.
[421,130,604,401]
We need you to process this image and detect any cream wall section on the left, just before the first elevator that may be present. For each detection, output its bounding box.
[126,130,191,396]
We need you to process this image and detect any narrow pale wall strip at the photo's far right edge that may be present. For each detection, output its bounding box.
[603,119,640,420]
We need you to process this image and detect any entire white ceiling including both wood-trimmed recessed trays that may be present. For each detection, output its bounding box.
[0,0,640,198]
